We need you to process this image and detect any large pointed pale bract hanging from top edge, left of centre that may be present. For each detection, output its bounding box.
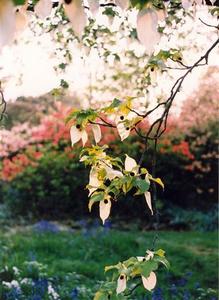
[63,0,87,38]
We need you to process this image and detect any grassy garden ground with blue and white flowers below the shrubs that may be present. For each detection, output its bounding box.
[0,223,218,300]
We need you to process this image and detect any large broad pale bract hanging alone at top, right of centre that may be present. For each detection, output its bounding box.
[137,8,160,54]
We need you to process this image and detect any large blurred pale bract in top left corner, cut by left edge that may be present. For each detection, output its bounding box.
[0,0,15,49]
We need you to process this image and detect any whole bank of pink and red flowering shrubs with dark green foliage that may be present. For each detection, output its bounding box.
[0,67,219,216]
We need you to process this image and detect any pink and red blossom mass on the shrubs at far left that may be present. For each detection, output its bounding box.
[0,104,70,181]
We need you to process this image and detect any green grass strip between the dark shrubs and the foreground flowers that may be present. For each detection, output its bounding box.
[0,229,218,299]
